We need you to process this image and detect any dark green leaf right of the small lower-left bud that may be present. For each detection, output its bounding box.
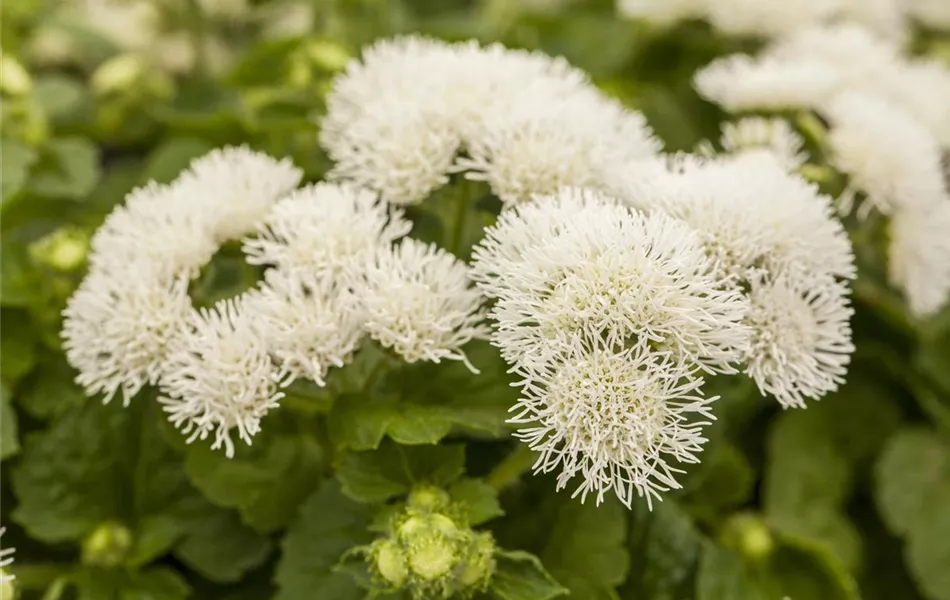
[175,509,272,582]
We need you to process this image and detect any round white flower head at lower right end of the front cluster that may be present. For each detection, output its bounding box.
[746,276,854,408]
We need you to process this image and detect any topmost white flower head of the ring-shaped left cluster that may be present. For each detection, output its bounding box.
[176,146,303,243]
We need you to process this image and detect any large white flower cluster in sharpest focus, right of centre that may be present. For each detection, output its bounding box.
[473,164,854,505]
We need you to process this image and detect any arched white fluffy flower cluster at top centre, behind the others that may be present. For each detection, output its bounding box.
[320,37,658,209]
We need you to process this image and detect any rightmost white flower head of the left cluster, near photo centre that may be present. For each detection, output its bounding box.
[357,238,487,372]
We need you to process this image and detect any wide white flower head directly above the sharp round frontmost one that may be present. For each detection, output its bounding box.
[473,189,747,373]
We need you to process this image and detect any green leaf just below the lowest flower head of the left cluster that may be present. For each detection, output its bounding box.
[185,431,322,532]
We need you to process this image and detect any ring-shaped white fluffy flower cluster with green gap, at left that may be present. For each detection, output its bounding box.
[62,147,486,456]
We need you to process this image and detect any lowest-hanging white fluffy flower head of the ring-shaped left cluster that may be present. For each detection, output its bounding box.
[159,300,283,458]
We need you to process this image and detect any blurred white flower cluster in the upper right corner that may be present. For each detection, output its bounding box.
[695,24,950,317]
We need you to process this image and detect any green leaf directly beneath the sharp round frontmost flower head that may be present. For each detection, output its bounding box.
[541,499,630,600]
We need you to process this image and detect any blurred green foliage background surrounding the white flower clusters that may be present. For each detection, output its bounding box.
[0,0,950,600]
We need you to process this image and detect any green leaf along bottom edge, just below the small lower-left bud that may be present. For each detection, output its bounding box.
[73,567,191,600]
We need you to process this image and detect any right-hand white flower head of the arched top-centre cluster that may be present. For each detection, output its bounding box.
[457,94,659,204]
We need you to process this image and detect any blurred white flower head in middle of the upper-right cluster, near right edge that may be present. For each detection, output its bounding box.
[823,93,946,214]
